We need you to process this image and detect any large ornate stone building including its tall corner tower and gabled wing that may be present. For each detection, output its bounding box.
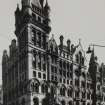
[2,0,104,105]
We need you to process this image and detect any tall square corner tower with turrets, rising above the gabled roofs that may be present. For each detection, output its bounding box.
[15,0,51,105]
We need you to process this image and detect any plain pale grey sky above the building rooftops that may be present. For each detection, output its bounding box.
[0,0,105,84]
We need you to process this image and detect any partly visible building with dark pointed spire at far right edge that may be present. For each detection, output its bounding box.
[89,49,105,105]
